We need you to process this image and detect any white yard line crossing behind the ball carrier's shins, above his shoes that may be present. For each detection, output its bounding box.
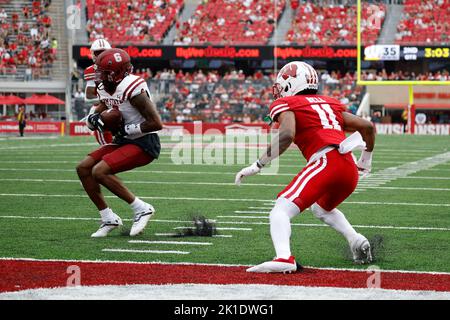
[0,193,450,208]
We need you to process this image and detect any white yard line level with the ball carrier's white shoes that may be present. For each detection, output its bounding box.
[0,216,450,231]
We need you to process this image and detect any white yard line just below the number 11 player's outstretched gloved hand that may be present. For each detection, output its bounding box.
[0,178,450,191]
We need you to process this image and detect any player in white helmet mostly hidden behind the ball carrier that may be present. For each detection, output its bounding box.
[84,39,113,145]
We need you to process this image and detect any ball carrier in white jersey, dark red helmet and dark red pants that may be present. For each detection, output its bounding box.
[77,49,162,237]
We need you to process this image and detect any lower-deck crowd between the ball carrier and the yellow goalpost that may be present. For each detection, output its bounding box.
[149,70,362,123]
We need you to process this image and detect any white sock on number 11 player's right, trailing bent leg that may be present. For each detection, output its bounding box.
[311,203,358,242]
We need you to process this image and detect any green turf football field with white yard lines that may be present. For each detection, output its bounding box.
[0,136,450,272]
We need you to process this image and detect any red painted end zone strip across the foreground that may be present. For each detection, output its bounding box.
[0,260,450,292]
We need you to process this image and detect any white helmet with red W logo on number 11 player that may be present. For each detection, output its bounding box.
[273,61,319,99]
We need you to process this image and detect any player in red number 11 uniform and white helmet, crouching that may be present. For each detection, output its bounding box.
[236,61,375,272]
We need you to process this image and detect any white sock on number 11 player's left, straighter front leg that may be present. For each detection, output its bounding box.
[270,198,300,259]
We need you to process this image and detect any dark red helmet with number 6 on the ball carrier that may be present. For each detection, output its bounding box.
[94,48,133,91]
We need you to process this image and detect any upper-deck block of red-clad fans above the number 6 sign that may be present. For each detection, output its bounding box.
[175,0,285,45]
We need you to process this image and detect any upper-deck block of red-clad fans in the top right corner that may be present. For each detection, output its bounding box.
[396,0,450,45]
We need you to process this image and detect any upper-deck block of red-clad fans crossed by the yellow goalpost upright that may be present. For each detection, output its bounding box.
[286,3,386,45]
